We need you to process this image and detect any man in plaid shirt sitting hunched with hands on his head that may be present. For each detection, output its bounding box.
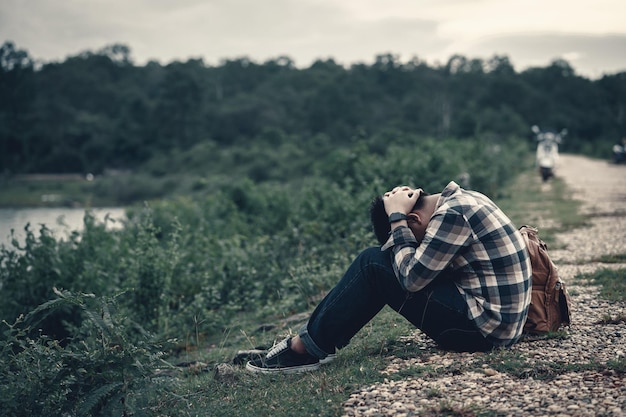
[246,182,531,373]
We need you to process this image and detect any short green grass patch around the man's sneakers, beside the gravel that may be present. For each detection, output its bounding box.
[151,308,420,416]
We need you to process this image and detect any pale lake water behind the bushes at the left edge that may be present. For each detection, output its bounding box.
[0,207,126,246]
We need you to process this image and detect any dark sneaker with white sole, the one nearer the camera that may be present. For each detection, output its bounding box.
[246,337,320,374]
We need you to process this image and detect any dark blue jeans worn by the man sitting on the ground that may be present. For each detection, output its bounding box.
[299,247,493,359]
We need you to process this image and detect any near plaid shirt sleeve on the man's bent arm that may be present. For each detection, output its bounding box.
[382,210,473,292]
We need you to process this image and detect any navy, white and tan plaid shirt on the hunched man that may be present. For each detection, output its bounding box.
[382,182,532,346]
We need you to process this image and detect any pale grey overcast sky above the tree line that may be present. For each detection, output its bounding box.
[0,0,626,78]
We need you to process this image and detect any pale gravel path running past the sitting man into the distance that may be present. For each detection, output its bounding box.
[344,155,626,416]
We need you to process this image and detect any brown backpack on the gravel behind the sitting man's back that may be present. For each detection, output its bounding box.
[519,225,571,334]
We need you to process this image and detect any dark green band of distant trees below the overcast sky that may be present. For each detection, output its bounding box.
[0,41,626,175]
